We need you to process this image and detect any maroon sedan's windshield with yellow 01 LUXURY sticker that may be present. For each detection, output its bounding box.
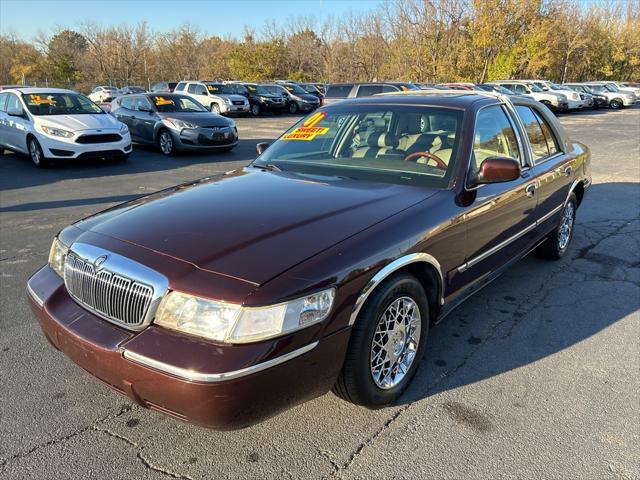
[254,105,463,188]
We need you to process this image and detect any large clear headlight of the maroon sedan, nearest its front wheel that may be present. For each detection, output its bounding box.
[155,288,335,343]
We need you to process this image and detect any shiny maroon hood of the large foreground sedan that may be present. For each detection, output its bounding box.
[76,167,437,285]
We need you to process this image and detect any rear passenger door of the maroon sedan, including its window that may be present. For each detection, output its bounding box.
[515,105,574,233]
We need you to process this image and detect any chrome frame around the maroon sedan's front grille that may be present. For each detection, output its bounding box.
[65,242,169,331]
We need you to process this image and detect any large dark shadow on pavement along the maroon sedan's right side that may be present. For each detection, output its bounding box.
[397,183,640,404]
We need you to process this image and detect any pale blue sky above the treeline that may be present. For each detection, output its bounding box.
[0,0,383,40]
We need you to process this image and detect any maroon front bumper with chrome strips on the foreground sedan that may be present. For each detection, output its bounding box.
[27,266,349,429]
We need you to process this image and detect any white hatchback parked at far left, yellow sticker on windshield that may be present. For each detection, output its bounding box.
[0,88,131,167]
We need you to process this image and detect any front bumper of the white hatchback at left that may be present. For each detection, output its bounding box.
[36,132,131,160]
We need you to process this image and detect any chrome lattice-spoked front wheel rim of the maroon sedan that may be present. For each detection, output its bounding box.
[369,297,421,390]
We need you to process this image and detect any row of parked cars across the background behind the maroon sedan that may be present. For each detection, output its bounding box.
[0,80,640,167]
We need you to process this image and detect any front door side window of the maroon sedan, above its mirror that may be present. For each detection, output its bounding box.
[473,105,520,168]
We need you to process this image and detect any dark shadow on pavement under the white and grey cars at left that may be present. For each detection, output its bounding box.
[0,138,272,191]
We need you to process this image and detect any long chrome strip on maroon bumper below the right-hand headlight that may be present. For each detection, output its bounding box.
[122,341,319,383]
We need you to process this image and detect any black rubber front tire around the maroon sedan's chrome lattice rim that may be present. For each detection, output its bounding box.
[333,273,429,408]
